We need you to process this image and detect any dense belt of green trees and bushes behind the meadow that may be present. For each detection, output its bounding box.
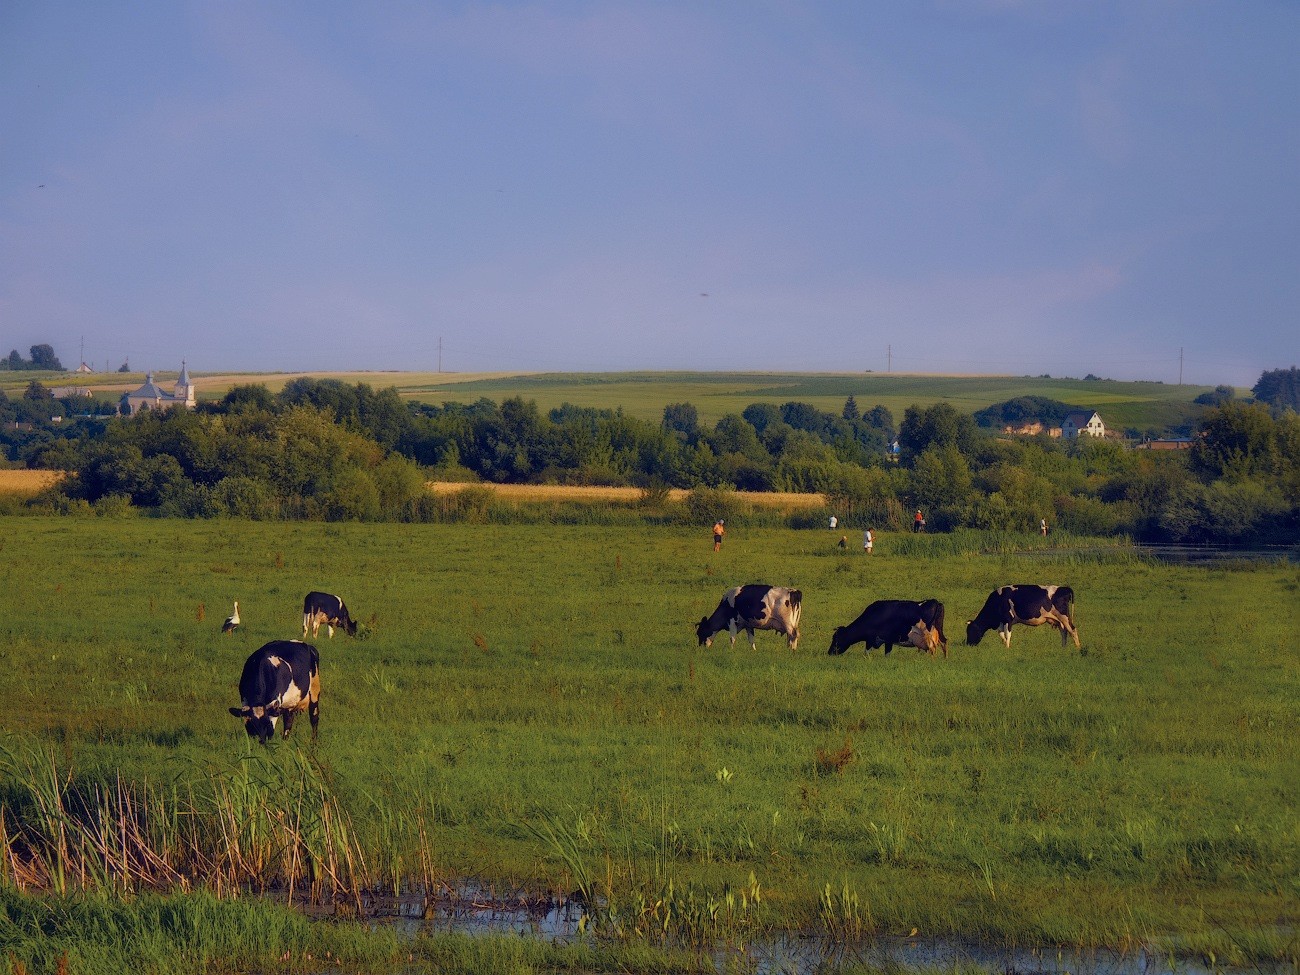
[0,378,1300,543]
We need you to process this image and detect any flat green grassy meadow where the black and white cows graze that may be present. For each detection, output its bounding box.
[0,514,1300,970]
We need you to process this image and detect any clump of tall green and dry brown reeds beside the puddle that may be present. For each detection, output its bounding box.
[0,746,372,907]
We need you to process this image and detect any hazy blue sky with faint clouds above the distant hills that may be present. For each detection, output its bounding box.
[0,0,1300,386]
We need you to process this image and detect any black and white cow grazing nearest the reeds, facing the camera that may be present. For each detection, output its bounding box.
[230,640,321,745]
